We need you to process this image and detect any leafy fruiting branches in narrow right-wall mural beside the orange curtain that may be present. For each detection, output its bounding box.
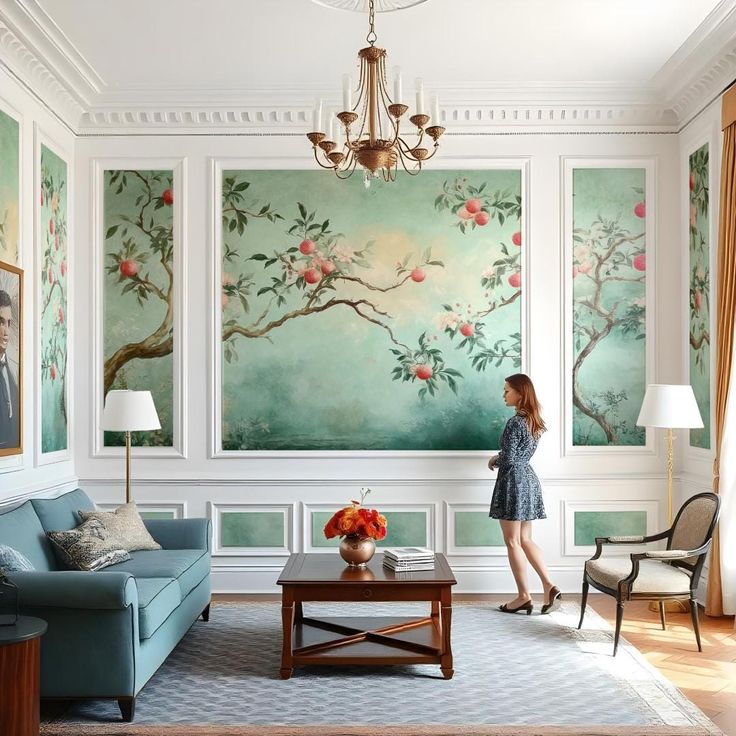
[689,146,710,366]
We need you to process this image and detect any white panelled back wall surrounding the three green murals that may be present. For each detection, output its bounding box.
[74,130,686,592]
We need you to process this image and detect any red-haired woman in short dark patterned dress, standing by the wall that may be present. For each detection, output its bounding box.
[488,373,562,615]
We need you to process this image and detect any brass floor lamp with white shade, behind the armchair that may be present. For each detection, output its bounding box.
[636,383,703,611]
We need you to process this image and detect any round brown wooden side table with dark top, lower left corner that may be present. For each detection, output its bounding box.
[0,616,46,736]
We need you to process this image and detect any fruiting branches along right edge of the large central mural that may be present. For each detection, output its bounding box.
[434,177,522,371]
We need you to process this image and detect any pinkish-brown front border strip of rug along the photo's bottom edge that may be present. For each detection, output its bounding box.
[41,723,723,736]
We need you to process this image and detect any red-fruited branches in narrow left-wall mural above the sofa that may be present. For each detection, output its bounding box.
[40,167,68,421]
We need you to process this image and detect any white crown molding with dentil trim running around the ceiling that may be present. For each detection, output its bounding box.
[0,0,736,136]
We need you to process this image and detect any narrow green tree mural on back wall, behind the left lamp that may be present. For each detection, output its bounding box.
[104,170,175,447]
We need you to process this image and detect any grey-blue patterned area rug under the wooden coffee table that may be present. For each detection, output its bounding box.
[41,601,721,736]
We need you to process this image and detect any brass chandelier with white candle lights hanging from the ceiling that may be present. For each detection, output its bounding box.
[307,0,445,186]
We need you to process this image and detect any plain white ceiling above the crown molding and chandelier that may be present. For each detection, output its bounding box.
[33,0,722,93]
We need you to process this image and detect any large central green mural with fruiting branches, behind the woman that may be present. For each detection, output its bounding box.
[220,170,522,451]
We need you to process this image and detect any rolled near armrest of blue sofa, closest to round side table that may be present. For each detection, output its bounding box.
[8,570,138,610]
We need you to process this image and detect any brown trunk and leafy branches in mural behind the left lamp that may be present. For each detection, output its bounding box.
[104,170,174,394]
